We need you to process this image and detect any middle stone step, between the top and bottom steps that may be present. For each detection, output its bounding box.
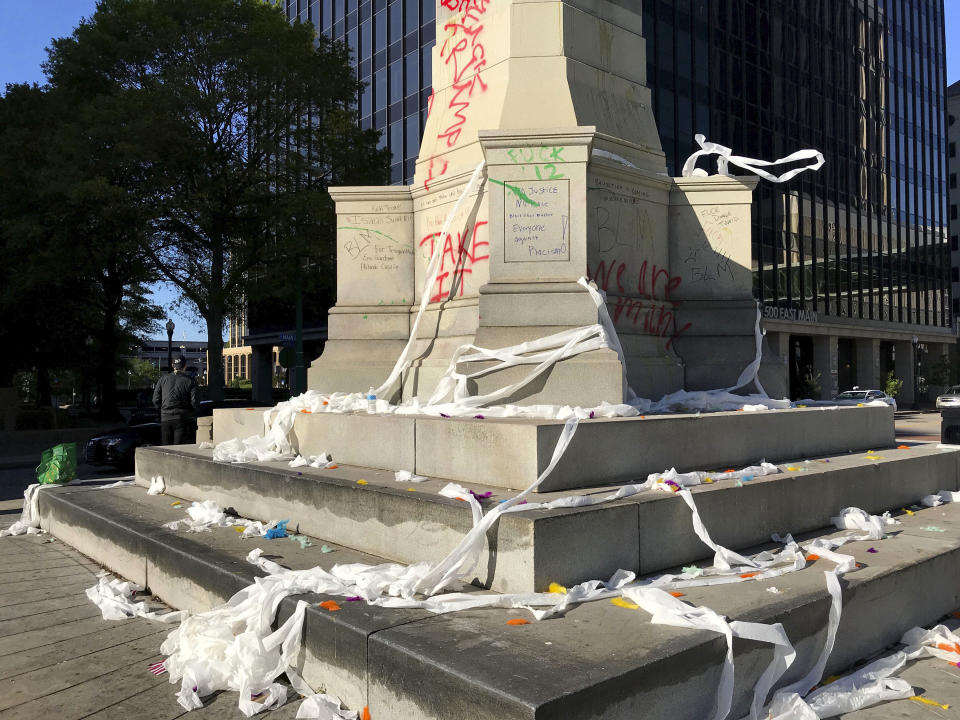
[136,445,960,592]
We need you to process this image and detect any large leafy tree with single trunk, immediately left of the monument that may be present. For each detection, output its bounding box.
[46,0,388,399]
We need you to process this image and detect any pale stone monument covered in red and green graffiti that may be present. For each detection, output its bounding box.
[316,0,777,407]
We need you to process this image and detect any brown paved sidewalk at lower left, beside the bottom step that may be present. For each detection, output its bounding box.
[0,503,300,720]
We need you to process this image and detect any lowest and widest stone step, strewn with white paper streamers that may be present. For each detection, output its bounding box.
[40,478,960,720]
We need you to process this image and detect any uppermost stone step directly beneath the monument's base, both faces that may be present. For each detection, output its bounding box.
[213,406,895,492]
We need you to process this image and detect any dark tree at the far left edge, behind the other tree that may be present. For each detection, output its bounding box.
[0,85,160,418]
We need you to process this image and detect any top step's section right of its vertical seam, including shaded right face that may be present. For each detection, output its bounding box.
[417,407,895,492]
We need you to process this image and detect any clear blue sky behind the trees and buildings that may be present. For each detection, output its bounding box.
[0,0,960,340]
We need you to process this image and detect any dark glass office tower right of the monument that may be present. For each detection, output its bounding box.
[643,0,952,327]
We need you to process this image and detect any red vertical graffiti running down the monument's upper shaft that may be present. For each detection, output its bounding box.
[437,0,490,148]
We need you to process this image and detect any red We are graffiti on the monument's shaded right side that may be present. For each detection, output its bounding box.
[590,260,692,349]
